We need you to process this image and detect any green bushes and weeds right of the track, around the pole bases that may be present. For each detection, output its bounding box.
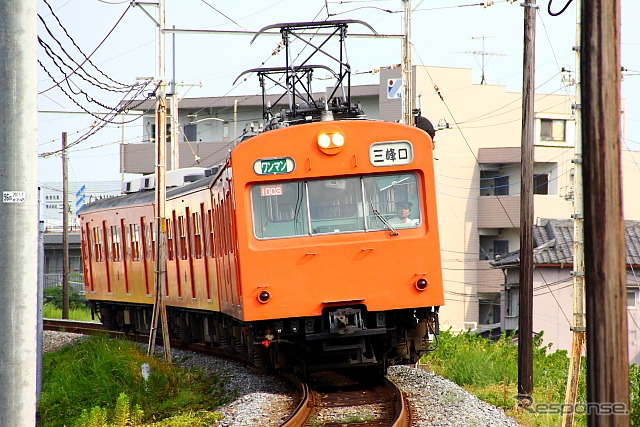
[422,331,640,426]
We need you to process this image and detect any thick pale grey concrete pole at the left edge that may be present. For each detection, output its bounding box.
[0,0,38,427]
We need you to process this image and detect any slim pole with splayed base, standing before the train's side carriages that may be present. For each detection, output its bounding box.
[147,0,171,363]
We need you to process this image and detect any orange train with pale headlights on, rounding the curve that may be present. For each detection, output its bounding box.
[79,119,444,372]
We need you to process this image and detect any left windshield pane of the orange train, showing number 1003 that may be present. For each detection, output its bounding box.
[251,181,309,239]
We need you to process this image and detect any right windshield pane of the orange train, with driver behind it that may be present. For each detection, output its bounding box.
[363,173,422,230]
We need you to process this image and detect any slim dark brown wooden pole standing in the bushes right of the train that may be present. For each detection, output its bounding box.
[518,0,537,407]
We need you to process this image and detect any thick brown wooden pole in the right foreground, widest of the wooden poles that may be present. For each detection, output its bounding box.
[580,0,630,427]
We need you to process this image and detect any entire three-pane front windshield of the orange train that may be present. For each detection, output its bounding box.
[251,173,422,239]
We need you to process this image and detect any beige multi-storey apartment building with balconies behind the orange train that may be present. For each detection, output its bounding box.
[121,67,640,330]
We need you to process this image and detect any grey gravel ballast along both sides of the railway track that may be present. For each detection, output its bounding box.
[43,331,518,427]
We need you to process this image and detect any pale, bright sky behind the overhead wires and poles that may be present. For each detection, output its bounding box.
[38,0,640,183]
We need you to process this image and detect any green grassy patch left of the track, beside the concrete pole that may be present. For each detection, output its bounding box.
[38,337,231,427]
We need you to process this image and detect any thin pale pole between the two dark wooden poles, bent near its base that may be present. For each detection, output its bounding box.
[562,0,586,427]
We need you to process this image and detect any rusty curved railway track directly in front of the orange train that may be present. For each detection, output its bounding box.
[283,371,411,427]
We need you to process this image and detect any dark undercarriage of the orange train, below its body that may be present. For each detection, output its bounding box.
[91,301,439,374]
